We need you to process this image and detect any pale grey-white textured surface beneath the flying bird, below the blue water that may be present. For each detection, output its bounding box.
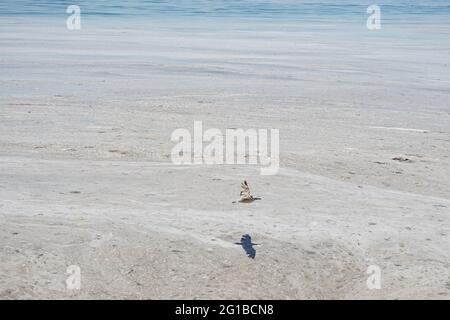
[0,19,450,299]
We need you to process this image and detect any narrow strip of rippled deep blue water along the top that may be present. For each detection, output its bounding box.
[0,0,450,20]
